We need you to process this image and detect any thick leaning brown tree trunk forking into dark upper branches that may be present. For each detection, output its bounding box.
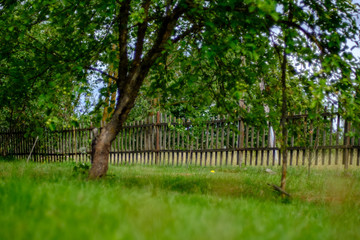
[89,0,190,179]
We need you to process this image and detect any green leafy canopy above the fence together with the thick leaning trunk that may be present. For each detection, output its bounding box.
[0,0,360,180]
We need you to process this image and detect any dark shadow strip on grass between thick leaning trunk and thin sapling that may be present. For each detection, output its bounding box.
[100,170,279,201]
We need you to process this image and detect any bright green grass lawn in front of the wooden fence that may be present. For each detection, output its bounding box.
[0,160,360,240]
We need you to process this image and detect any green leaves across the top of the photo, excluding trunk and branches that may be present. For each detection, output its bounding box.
[0,0,359,127]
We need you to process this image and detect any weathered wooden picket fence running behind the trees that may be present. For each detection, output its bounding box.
[0,113,360,166]
